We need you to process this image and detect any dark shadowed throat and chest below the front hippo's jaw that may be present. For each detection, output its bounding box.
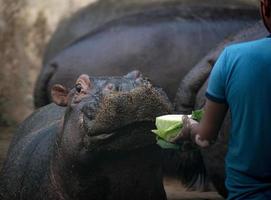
[51,145,166,200]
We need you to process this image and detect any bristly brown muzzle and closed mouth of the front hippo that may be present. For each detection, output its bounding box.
[83,85,172,150]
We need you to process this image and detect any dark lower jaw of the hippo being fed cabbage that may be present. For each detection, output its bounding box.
[83,117,156,151]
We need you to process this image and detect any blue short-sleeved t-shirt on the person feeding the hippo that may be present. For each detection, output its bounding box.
[206,37,271,199]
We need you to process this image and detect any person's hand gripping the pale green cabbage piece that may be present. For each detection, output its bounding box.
[170,115,199,144]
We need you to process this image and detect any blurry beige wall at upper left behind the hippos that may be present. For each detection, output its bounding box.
[0,0,95,126]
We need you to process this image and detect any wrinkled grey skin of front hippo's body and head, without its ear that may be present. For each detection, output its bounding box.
[0,72,172,200]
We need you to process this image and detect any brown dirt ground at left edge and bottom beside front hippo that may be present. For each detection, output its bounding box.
[0,127,223,200]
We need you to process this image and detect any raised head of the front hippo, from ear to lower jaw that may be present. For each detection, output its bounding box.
[52,71,171,156]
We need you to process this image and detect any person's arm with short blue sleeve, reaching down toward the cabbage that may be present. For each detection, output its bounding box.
[195,49,230,146]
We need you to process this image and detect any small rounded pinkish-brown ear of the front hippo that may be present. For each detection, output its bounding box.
[51,84,69,106]
